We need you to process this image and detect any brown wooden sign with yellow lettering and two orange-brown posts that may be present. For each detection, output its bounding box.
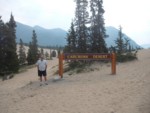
[59,53,116,78]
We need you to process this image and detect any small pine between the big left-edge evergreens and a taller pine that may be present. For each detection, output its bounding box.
[19,39,26,65]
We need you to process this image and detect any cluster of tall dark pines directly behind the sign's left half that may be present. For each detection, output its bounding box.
[65,0,108,53]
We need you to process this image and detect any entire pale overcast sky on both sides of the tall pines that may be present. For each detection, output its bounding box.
[0,0,150,45]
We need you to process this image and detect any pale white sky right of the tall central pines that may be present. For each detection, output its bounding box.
[104,0,150,44]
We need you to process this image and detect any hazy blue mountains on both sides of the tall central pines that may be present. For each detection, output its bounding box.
[16,22,140,48]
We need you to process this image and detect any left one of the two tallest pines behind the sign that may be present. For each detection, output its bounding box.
[75,0,89,53]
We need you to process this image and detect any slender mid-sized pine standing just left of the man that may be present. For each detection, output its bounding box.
[27,30,39,65]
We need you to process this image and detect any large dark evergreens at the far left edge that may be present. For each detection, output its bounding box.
[0,14,19,76]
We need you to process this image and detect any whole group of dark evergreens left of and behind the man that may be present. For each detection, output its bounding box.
[0,14,52,76]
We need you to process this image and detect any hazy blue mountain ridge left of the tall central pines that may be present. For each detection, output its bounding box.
[16,22,67,46]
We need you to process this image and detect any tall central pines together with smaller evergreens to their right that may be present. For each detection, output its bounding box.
[64,0,138,65]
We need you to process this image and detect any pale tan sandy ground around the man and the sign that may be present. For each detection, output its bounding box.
[0,49,150,113]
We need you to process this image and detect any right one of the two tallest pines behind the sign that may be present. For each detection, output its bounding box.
[90,0,108,53]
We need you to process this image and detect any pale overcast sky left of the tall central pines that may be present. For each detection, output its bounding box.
[0,0,75,30]
